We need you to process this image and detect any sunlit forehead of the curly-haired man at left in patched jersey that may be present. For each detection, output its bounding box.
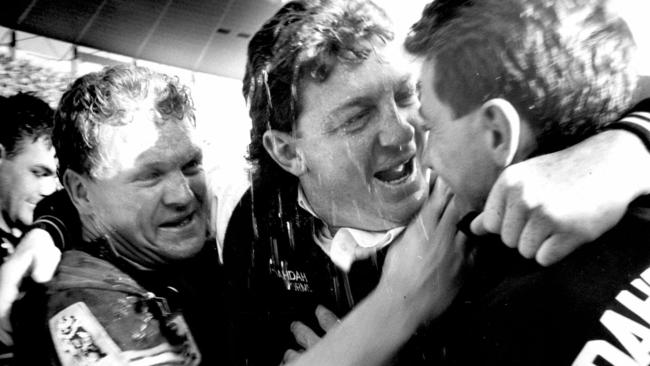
[97,115,200,177]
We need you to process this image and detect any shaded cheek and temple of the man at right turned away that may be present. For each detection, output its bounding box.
[419,60,498,212]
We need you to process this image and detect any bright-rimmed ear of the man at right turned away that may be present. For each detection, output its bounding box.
[479,98,521,167]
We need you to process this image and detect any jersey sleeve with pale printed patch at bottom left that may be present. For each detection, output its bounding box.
[47,288,201,366]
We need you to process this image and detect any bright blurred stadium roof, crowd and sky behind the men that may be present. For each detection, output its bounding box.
[0,0,650,201]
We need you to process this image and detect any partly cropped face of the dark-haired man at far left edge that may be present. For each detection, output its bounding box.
[0,137,57,230]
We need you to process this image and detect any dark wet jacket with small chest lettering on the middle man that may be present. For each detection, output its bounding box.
[223,186,436,365]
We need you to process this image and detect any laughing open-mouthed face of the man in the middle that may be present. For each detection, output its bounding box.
[296,47,428,230]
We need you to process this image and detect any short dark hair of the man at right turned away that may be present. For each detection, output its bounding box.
[405,0,636,153]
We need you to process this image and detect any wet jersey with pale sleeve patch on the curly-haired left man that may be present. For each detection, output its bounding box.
[12,242,223,365]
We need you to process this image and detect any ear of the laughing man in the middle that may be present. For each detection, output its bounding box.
[262,130,306,177]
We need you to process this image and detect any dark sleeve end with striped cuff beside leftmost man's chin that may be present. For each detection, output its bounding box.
[31,190,81,250]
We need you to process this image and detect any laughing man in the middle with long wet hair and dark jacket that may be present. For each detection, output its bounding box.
[224,1,648,364]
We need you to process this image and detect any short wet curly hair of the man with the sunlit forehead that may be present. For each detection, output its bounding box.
[52,65,196,179]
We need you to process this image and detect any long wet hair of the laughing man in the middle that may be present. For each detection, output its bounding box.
[243,0,393,192]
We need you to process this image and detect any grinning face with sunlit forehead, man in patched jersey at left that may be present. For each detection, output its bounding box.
[86,112,206,265]
